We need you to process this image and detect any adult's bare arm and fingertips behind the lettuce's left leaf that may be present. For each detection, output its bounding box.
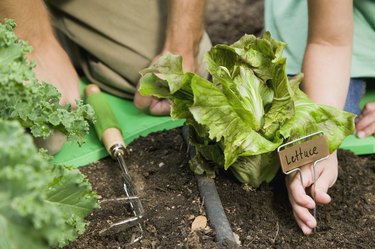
[134,0,205,115]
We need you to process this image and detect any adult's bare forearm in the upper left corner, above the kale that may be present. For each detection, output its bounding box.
[0,0,53,47]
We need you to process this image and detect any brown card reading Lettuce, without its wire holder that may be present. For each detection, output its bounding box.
[279,136,329,173]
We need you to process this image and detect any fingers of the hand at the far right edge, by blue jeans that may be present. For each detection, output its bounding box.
[356,102,375,138]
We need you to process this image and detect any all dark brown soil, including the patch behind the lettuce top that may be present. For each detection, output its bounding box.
[66,0,375,249]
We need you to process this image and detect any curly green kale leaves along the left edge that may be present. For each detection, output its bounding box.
[0,20,98,249]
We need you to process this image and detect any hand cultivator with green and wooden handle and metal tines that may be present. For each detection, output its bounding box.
[86,84,144,243]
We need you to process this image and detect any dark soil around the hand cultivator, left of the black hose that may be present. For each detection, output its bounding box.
[65,129,220,248]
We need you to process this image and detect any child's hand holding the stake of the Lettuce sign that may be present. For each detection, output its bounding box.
[286,151,338,235]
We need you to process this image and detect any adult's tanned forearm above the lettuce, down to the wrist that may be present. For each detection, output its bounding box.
[164,0,205,55]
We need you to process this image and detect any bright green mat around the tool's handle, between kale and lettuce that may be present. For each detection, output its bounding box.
[52,82,184,167]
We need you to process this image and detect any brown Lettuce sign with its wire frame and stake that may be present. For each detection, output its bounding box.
[277,131,330,232]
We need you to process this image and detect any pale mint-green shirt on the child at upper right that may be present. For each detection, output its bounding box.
[265,0,375,77]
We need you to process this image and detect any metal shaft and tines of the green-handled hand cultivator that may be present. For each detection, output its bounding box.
[99,144,144,244]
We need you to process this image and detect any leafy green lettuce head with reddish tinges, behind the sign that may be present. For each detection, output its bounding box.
[140,32,354,187]
